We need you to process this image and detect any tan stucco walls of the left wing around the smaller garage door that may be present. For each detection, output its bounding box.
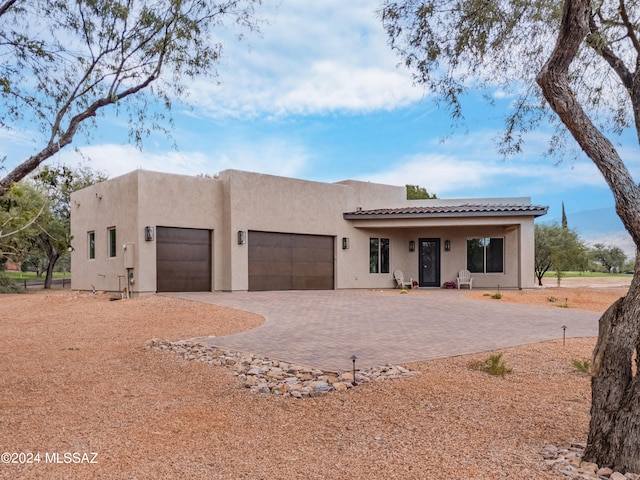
[71,170,222,294]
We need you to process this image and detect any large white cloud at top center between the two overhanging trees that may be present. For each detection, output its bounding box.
[186,0,423,117]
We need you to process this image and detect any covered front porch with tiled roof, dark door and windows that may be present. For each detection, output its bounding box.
[344,204,547,289]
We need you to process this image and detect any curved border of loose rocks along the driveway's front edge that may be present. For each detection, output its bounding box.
[145,338,415,398]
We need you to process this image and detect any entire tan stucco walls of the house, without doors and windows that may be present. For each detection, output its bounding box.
[72,170,534,294]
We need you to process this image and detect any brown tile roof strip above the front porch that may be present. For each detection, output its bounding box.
[343,203,549,220]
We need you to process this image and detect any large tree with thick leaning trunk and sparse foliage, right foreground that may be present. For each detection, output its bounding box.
[380,0,640,466]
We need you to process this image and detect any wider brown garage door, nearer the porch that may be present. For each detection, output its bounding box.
[247,231,334,291]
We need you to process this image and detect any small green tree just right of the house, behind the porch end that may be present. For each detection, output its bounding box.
[534,222,587,286]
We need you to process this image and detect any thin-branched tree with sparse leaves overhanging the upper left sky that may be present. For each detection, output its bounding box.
[0,0,259,196]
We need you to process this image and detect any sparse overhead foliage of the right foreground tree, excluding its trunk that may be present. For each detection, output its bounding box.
[379,0,635,155]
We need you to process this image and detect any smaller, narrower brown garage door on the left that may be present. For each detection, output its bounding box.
[156,227,211,292]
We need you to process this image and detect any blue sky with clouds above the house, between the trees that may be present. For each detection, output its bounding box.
[0,0,640,231]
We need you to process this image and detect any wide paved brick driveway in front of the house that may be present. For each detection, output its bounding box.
[166,290,600,371]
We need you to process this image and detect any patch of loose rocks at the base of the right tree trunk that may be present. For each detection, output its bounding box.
[541,443,640,480]
